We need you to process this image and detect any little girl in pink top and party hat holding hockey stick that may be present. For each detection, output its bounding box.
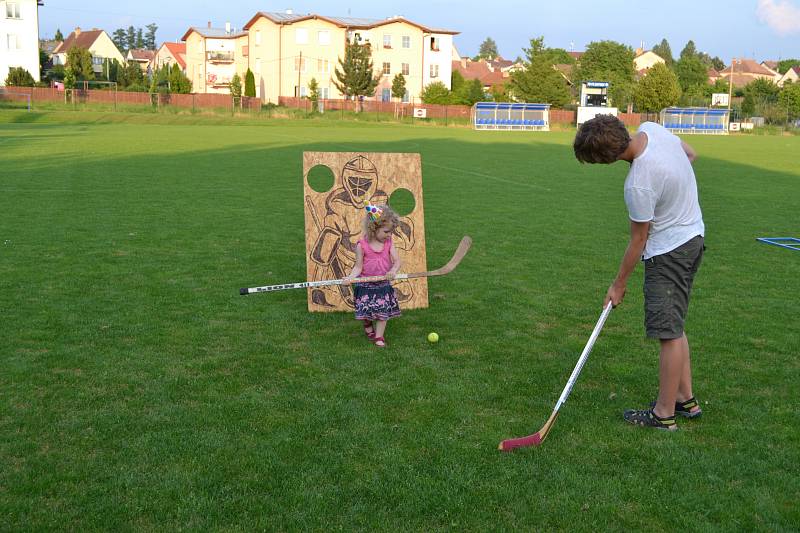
[344,205,400,348]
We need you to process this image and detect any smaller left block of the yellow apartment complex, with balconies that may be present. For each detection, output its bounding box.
[181,22,248,94]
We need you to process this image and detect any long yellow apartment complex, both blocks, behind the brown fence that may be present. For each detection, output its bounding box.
[182,10,457,103]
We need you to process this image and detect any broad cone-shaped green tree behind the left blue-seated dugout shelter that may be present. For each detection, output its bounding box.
[510,37,572,107]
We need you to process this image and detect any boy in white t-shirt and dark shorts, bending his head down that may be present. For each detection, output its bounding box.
[573,115,705,431]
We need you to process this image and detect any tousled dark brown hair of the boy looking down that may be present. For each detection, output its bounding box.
[572,115,631,163]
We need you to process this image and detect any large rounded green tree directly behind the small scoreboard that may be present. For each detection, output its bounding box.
[575,41,635,108]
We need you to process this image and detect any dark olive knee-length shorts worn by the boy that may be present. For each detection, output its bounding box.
[644,235,705,340]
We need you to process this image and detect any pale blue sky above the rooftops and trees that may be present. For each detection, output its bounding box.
[39,0,800,64]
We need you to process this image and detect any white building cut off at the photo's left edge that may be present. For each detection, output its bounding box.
[0,0,44,85]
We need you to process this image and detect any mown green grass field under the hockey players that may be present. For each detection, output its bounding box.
[0,111,800,531]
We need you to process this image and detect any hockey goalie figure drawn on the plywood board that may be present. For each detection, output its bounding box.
[306,155,414,307]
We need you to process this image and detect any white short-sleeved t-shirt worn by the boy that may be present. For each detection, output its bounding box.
[625,122,705,259]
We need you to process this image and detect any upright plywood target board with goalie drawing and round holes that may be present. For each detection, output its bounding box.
[303,152,428,312]
